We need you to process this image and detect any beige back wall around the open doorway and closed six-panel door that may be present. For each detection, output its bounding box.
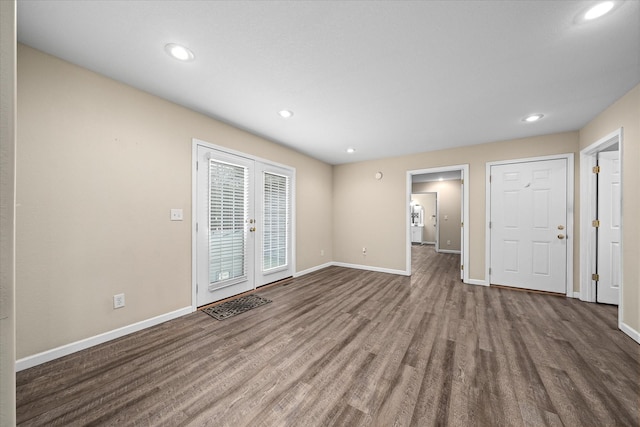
[333,132,578,284]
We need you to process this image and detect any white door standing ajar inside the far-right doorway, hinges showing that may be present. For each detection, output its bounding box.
[596,151,622,305]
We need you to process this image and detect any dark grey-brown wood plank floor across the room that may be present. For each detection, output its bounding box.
[17,246,640,427]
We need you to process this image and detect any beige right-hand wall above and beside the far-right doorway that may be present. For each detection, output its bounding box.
[580,85,640,332]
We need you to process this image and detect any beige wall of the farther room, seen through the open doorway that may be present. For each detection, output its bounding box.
[411,179,462,251]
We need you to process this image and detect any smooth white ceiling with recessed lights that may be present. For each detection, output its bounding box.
[17,0,640,164]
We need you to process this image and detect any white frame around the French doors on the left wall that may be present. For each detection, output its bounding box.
[191,138,297,311]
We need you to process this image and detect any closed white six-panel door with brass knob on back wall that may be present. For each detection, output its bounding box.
[490,159,567,293]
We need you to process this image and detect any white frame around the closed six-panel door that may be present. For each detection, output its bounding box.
[484,153,576,298]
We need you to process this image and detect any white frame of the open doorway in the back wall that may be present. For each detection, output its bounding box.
[404,164,470,285]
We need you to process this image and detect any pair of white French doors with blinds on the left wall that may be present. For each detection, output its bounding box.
[194,145,294,306]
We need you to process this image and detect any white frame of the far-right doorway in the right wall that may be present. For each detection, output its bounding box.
[580,128,624,308]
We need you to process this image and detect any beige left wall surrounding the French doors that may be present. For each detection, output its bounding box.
[16,45,333,358]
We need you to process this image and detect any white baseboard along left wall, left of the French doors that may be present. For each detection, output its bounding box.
[16,306,193,372]
